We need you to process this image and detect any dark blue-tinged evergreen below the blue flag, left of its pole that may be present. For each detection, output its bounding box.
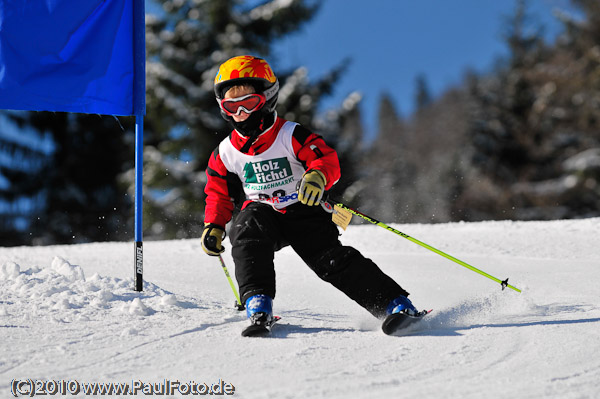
[2,112,133,245]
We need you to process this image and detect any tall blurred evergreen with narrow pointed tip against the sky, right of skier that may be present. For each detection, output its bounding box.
[459,0,545,220]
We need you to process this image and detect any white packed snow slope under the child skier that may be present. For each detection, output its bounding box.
[0,219,600,399]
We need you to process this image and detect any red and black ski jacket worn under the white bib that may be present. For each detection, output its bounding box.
[204,117,341,227]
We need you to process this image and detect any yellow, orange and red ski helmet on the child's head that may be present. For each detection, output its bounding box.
[214,55,279,112]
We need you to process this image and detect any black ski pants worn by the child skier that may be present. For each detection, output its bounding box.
[229,202,408,317]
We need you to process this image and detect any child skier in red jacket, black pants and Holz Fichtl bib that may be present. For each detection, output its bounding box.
[201,56,418,336]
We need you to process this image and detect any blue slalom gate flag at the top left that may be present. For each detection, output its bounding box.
[0,0,145,115]
